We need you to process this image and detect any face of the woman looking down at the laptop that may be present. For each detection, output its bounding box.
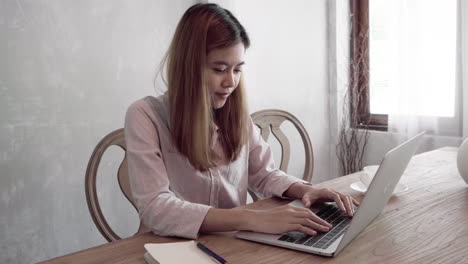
[205,42,245,109]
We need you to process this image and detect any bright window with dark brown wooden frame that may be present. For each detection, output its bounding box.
[350,0,457,130]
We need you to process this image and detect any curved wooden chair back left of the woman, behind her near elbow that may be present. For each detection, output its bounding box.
[85,128,142,242]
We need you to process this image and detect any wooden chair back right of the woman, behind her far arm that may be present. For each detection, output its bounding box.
[249,109,314,201]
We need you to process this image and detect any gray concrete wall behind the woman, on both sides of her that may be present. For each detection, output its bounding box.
[0,0,334,263]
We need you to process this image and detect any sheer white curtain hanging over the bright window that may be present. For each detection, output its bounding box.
[369,0,468,138]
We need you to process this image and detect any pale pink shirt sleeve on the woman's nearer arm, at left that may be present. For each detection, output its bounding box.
[125,100,210,239]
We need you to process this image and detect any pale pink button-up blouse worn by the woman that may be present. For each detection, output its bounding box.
[125,93,303,238]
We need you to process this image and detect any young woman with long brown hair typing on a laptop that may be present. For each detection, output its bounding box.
[125,4,358,238]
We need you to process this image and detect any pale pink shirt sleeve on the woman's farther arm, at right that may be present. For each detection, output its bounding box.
[245,117,307,198]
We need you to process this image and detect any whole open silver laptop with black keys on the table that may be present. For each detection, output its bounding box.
[235,132,424,257]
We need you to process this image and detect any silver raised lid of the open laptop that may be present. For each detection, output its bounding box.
[334,132,425,255]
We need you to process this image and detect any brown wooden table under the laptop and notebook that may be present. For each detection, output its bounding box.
[42,148,468,264]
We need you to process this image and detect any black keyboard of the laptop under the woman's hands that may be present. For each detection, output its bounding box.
[278,203,357,249]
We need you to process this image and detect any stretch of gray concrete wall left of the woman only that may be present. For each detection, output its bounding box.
[0,0,194,263]
